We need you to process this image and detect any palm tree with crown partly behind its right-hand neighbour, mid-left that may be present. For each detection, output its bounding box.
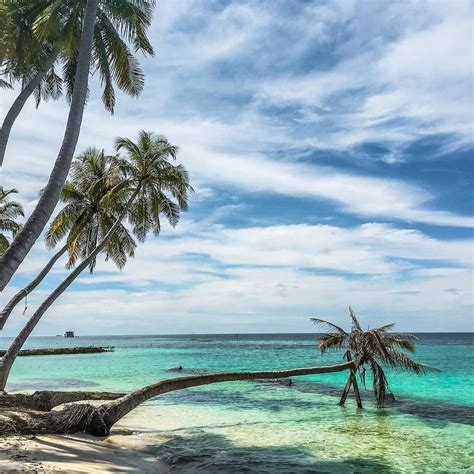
[0,148,136,329]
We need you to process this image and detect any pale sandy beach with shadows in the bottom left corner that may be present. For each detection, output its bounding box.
[0,435,170,474]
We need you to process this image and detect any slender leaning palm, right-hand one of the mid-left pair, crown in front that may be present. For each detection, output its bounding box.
[0,131,193,391]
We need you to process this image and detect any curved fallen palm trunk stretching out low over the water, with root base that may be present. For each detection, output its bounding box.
[0,362,354,436]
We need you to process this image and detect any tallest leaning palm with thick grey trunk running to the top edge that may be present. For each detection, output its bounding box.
[0,0,154,291]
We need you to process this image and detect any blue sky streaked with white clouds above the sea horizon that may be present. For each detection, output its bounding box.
[0,0,474,335]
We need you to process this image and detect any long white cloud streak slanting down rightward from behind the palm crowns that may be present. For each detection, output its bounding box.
[5,103,473,227]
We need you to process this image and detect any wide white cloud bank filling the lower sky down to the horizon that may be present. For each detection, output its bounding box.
[2,218,472,334]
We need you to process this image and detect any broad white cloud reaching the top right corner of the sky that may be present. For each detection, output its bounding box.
[258,0,474,149]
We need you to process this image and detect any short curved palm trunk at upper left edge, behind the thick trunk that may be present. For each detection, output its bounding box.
[0,47,59,167]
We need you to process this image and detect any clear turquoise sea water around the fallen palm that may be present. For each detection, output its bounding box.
[0,334,474,472]
